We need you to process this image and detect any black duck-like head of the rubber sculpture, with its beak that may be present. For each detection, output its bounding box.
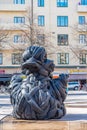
[22,46,54,76]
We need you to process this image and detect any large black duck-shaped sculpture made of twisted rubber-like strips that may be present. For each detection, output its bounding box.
[9,46,68,120]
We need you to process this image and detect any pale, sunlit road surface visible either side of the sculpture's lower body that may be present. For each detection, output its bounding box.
[0,91,87,121]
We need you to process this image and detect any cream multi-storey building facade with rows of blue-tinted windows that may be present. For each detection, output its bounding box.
[0,0,87,79]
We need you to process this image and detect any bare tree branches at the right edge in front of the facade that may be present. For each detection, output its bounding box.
[69,24,87,65]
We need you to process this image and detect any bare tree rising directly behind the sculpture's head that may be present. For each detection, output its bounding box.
[9,9,56,53]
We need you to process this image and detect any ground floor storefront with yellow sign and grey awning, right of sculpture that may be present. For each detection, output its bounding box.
[54,67,87,83]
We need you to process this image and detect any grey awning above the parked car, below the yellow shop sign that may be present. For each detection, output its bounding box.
[69,74,87,80]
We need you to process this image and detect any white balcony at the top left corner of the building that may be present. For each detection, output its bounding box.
[0,4,27,12]
